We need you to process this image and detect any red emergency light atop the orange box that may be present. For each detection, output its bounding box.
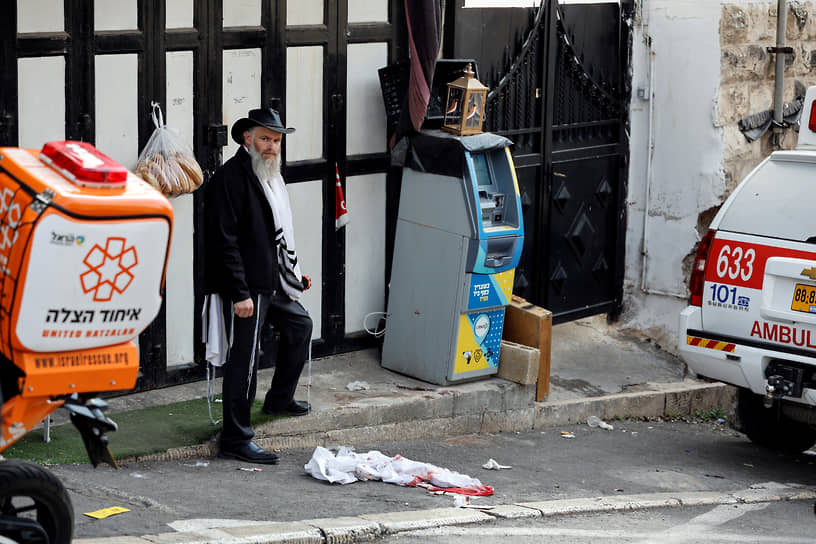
[40,140,128,189]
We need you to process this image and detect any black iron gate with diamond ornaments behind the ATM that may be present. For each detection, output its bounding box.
[446,0,630,322]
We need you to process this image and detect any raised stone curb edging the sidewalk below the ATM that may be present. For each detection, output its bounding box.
[120,380,736,462]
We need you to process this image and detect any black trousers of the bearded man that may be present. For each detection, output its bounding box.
[221,294,312,448]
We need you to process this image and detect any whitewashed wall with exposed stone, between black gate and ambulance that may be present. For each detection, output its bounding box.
[620,0,816,350]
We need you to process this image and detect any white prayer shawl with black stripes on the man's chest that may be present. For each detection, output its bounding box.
[261,174,303,300]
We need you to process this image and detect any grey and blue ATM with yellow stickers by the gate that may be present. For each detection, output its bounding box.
[382,131,524,385]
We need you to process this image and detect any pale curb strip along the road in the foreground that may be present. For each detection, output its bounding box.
[74,484,816,544]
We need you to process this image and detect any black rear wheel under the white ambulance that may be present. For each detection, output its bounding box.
[737,389,816,453]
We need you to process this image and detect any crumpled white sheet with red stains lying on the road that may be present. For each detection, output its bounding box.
[303,446,493,496]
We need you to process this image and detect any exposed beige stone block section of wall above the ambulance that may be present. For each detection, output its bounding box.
[715,1,816,196]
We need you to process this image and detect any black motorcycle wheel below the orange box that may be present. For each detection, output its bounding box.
[0,459,74,544]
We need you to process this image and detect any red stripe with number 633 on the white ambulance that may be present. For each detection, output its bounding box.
[705,237,816,288]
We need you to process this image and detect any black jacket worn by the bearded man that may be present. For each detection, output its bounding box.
[204,147,280,302]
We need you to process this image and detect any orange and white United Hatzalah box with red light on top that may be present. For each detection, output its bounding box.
[0,141,173,393]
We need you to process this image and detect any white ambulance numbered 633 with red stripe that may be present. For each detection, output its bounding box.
[679,87,816,452]
